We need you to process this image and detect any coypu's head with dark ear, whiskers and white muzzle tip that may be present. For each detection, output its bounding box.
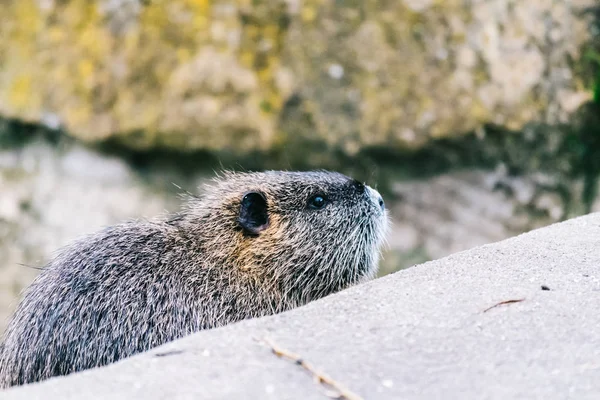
[188,171,387,304]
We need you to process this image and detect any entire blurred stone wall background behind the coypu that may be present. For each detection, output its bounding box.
[0,0,600,331]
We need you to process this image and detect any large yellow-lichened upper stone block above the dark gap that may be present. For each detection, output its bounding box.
[0,0,595,154]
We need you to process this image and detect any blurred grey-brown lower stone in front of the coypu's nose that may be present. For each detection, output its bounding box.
[382,168,582,272]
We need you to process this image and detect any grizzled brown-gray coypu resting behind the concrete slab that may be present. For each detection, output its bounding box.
[0,171,387,387]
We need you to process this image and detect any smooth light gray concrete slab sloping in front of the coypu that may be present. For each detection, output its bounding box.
[0,214,600,400]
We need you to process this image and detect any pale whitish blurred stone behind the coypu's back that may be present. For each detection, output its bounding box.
[0,141,177,331]
